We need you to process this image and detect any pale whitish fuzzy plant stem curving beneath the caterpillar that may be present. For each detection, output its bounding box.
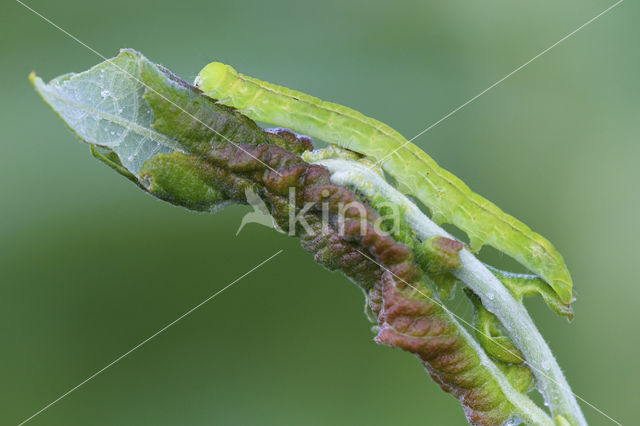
[317,159,587,425]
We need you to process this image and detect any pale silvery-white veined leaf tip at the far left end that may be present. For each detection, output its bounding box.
[30,50,175,175]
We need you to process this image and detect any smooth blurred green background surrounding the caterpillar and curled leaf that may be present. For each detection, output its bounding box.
[0,0,640,425]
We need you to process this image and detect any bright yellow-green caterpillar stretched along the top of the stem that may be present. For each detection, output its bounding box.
[196,62,572,304]
